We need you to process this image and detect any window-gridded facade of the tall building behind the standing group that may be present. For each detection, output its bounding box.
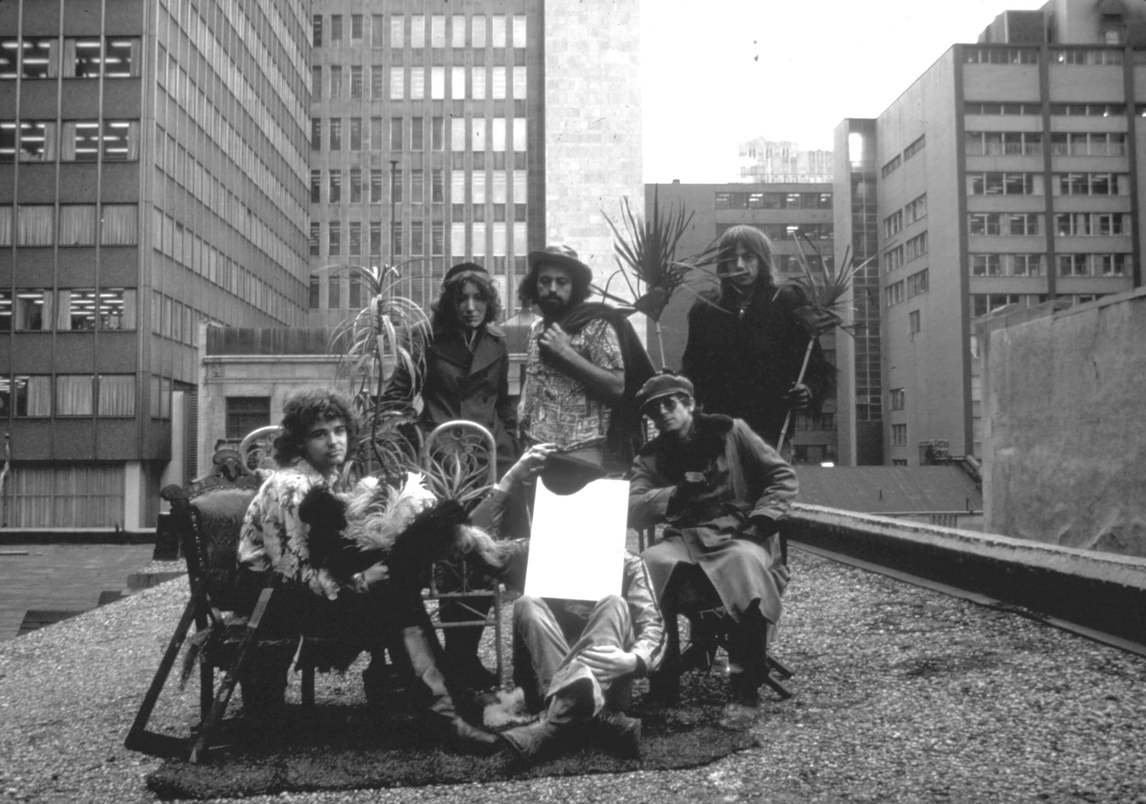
[308,0,544,323]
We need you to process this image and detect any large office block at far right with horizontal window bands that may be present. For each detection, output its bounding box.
[852,0,1146,465]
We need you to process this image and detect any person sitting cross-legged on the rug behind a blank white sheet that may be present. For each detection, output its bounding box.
[471,444,665,763]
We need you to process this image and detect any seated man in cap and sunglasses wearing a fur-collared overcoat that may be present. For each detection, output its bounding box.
[629,373,796,708]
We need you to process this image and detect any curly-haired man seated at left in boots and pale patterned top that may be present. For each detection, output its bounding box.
[238,391,497,752]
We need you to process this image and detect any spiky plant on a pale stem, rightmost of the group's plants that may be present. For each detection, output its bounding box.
[776,230,874,451]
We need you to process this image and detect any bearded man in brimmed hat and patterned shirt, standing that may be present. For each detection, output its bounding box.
[518,245,652,478]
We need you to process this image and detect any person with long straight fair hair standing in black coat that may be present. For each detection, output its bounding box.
[681,226,832,444]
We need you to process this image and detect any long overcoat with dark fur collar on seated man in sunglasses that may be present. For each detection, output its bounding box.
[629,413,798,623]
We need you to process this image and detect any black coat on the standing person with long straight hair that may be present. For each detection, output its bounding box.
[681,283,833,444]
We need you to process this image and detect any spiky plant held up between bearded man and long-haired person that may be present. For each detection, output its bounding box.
[598,190,715,365]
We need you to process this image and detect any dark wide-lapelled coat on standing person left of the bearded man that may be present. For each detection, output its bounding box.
[382,326,517,468]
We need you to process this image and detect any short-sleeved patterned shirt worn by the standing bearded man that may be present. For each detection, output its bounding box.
[518,318,625,449]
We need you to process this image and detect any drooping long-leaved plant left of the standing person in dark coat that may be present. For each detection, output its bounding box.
[331,266,431,481]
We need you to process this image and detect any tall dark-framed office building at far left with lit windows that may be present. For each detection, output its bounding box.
[0,0,311,529]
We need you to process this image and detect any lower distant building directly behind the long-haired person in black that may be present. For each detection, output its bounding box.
[645,182,848,464]
